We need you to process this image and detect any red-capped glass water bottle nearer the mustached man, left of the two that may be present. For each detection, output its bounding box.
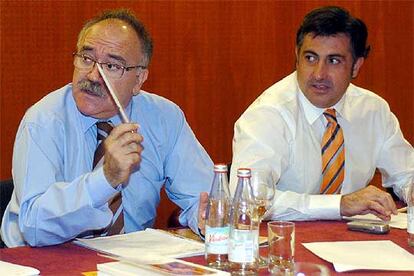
[205,164,230,270]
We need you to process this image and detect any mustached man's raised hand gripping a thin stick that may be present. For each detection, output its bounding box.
[103,123,143,188]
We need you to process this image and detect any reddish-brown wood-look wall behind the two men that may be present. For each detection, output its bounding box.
[0,1,414,226]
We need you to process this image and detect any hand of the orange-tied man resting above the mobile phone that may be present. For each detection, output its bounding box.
[341,185,397,221]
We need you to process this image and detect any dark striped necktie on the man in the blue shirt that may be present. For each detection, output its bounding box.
[93,122,124,236]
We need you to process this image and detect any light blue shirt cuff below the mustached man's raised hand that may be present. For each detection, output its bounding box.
[85,166,122,208]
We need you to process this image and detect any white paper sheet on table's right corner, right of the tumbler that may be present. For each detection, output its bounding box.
[302,240,414,272]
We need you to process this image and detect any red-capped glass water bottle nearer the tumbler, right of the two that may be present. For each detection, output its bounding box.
[229,168,259,275]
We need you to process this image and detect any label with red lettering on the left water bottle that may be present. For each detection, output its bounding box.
[205,225,230,254]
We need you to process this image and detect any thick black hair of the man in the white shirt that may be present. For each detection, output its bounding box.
[296,6,370,60]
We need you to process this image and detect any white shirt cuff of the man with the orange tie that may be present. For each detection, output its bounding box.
[308,195,342,219]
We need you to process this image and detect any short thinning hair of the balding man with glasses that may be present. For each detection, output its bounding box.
[78,9,153,66]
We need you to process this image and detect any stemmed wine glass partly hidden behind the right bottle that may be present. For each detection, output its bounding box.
[250,168,275,267]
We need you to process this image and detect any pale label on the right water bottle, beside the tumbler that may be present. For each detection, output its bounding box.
[229,229,259,263]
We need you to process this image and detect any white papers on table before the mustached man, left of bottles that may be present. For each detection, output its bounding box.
[75,228,204,263]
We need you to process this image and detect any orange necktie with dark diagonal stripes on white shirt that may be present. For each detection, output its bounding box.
[320,109,345,194]
